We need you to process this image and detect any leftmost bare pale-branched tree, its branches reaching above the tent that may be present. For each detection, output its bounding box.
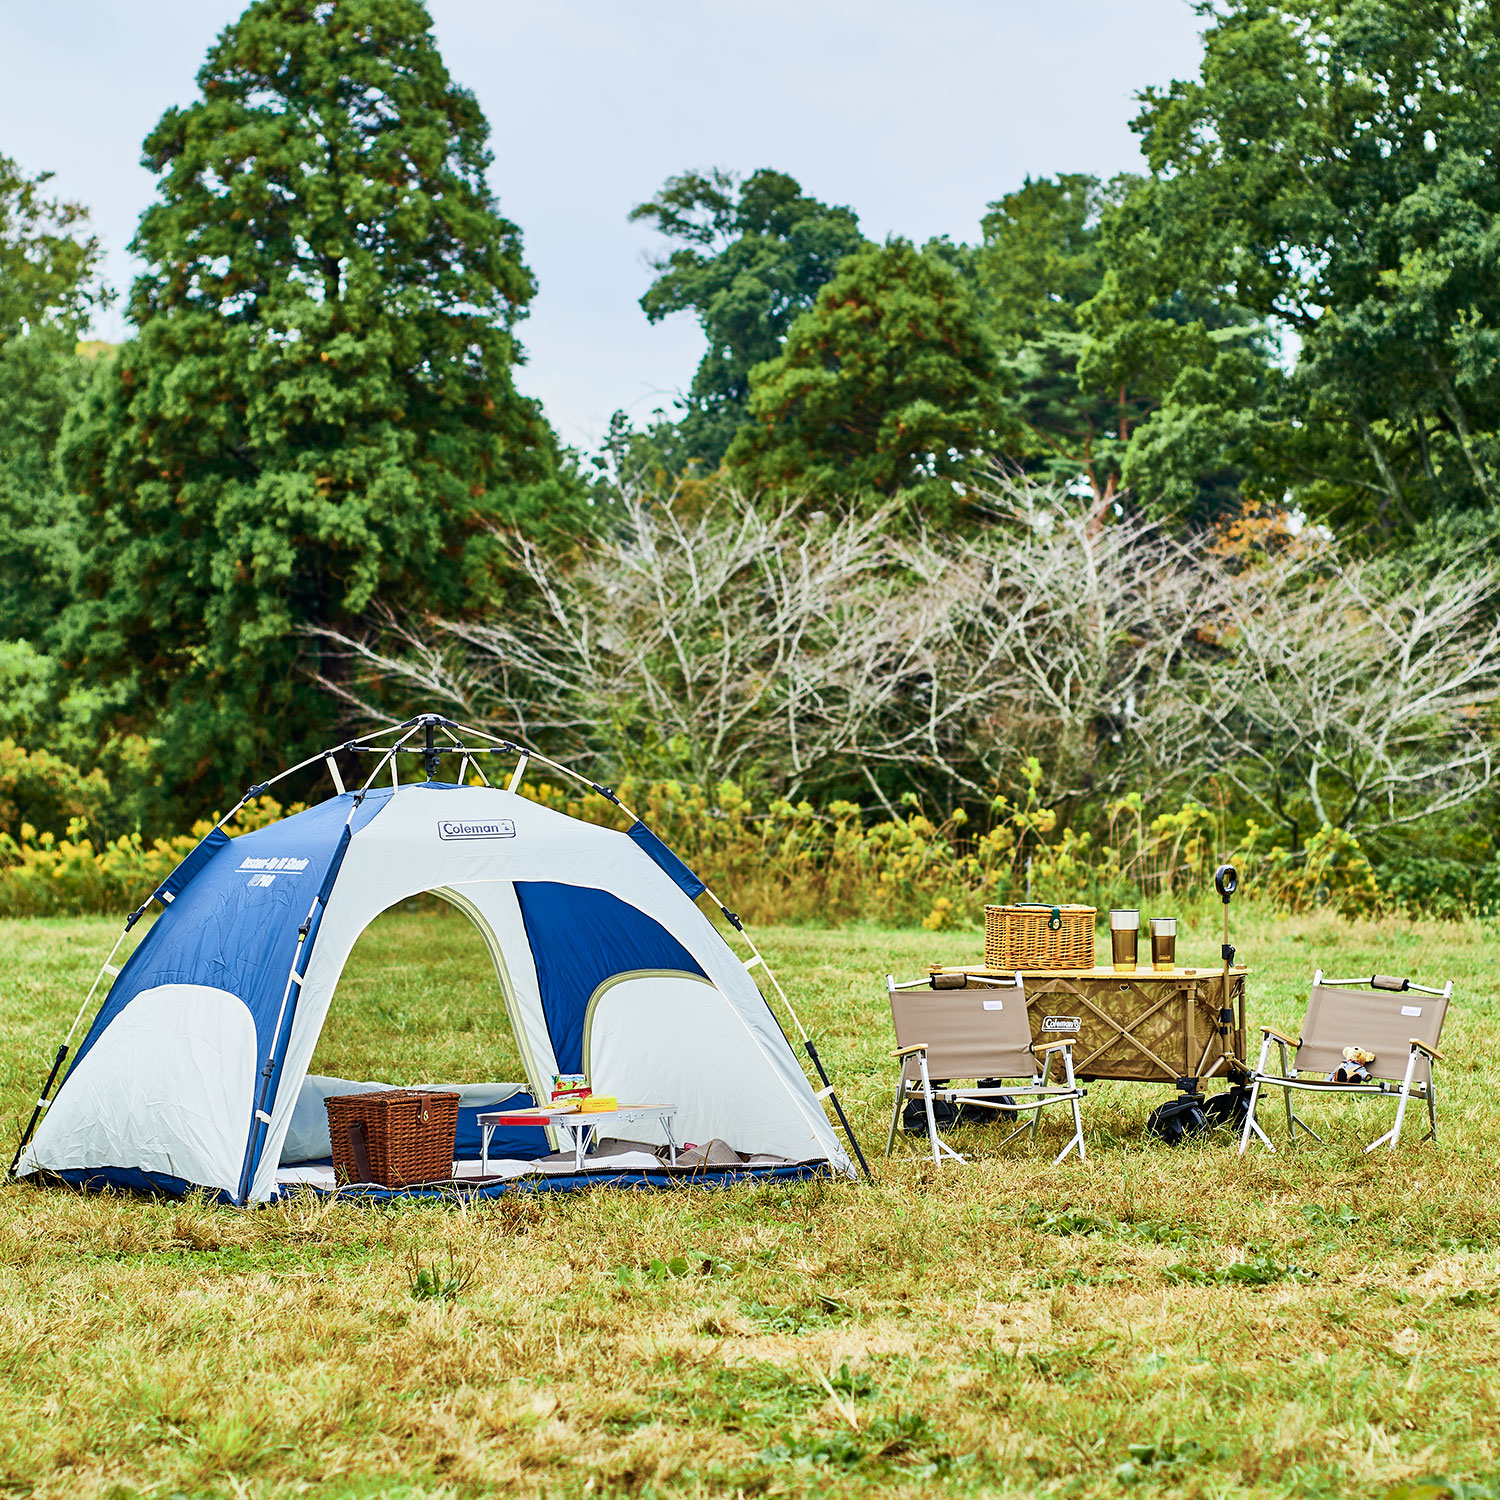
[315,494,1002,795]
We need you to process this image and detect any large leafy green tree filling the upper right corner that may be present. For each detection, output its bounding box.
[1085,0,1500,534]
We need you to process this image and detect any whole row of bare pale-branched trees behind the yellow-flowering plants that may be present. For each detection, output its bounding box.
[310,477,1500,843]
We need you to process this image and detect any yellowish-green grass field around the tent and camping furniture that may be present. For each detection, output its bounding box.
[0,911,1500,1500]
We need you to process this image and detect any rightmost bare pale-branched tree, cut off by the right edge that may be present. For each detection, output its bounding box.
[1182,552,1500,848]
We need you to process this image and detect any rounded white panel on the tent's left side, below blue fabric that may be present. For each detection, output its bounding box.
[23,984,257,1194]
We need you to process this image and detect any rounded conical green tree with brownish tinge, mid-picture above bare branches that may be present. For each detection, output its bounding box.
[728,240,1014,521]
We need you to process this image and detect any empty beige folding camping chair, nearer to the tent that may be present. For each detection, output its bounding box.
[885,974,1085,1167]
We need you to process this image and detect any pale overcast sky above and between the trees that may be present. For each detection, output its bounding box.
[0,0,1199,449]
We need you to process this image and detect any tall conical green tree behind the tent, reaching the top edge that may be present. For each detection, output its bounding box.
[62,0,575,816]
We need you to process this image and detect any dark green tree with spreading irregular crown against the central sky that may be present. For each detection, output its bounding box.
[630,168,867,468]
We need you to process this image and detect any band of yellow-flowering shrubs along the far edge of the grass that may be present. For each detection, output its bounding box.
[0,765,1440,932]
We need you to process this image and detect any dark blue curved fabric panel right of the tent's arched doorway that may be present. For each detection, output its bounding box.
[516,881,707,1073]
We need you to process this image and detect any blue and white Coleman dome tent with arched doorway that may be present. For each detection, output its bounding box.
[14,716,852,1205]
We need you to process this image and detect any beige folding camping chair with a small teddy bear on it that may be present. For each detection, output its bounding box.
[1239,969,1454,1157]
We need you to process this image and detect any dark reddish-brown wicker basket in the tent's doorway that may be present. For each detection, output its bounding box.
[323,1089,459,1188]
